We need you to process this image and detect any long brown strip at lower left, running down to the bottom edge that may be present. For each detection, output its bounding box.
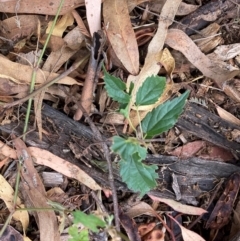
[13,138,60,241]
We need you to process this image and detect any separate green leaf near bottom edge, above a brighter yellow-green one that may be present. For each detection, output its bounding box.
[73,211,106,232]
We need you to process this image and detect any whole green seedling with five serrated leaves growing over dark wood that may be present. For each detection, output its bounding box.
[104,68,189,196]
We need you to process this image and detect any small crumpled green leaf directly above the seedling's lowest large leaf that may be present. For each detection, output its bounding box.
[111,136,147,160]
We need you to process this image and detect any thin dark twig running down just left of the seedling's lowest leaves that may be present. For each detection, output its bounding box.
[77,102,120,232]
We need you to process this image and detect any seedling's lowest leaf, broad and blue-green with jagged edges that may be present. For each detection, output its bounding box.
[120,153,158,196]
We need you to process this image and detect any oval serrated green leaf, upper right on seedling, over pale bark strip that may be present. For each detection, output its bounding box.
[136,75,166,106]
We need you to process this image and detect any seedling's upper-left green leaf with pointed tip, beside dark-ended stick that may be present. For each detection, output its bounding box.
[103,67,130,104]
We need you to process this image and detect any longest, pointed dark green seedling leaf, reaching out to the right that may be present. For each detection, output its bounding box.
[142,91,189,138]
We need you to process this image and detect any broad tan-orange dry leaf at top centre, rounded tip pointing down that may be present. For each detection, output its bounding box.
[103,0,139,75]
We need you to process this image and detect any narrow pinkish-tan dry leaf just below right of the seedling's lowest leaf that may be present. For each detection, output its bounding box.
[148,195,207,215]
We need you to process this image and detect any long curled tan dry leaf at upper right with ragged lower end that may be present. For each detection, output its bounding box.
[165,29,240,88]
